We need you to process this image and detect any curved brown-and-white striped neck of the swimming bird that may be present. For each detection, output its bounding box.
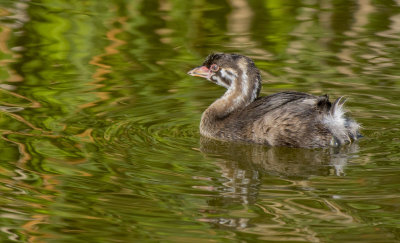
[200,69,261,135]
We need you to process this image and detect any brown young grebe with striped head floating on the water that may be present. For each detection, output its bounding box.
[188,53,360,148]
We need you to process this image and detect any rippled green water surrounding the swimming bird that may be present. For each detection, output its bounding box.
[0,0,400,242]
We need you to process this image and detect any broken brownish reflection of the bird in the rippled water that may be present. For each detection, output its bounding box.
[200,137,359,228]
